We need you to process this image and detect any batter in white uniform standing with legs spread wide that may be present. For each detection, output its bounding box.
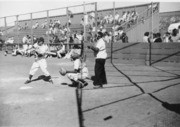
[25,37,53,84]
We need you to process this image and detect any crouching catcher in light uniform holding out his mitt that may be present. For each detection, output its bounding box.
[59,52,89,88]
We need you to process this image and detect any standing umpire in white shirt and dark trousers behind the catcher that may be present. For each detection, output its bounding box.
[87,32,107,89]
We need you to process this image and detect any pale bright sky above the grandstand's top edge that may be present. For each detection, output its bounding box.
[0,0,180,25]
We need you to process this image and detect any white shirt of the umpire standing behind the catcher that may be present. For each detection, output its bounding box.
[96,38,107,59]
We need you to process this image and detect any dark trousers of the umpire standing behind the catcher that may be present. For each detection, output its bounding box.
[93,59,107,86]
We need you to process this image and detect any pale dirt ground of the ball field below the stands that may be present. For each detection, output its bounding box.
[0,52,180,127]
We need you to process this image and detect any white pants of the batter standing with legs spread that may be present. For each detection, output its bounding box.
[29,58,50,76]
